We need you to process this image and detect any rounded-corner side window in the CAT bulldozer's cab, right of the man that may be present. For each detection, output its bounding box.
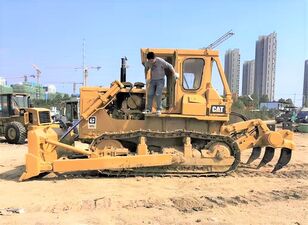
[182,58,204,90]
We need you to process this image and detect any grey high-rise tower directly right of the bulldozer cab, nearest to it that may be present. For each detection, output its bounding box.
[225,48,240,95]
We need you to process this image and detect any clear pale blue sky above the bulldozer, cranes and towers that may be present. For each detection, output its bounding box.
[0,0,308,103]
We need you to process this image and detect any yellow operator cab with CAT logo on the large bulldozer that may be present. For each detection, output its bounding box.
[141,49,232,121]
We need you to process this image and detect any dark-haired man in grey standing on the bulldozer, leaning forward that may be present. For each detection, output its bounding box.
[144,52,179,115]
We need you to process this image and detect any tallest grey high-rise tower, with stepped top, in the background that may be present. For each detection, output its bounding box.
[254,32,277,101]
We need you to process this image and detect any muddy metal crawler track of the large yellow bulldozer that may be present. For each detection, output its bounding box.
[90,130,240,177]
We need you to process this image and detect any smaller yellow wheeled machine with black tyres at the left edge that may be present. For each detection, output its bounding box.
[0,93,51,144]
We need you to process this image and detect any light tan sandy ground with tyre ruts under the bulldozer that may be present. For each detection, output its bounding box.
[0,134,308,225]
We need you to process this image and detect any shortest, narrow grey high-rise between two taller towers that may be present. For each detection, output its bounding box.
[242,60,255,95]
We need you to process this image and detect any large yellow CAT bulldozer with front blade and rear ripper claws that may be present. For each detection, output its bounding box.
[20,49,295,181]
